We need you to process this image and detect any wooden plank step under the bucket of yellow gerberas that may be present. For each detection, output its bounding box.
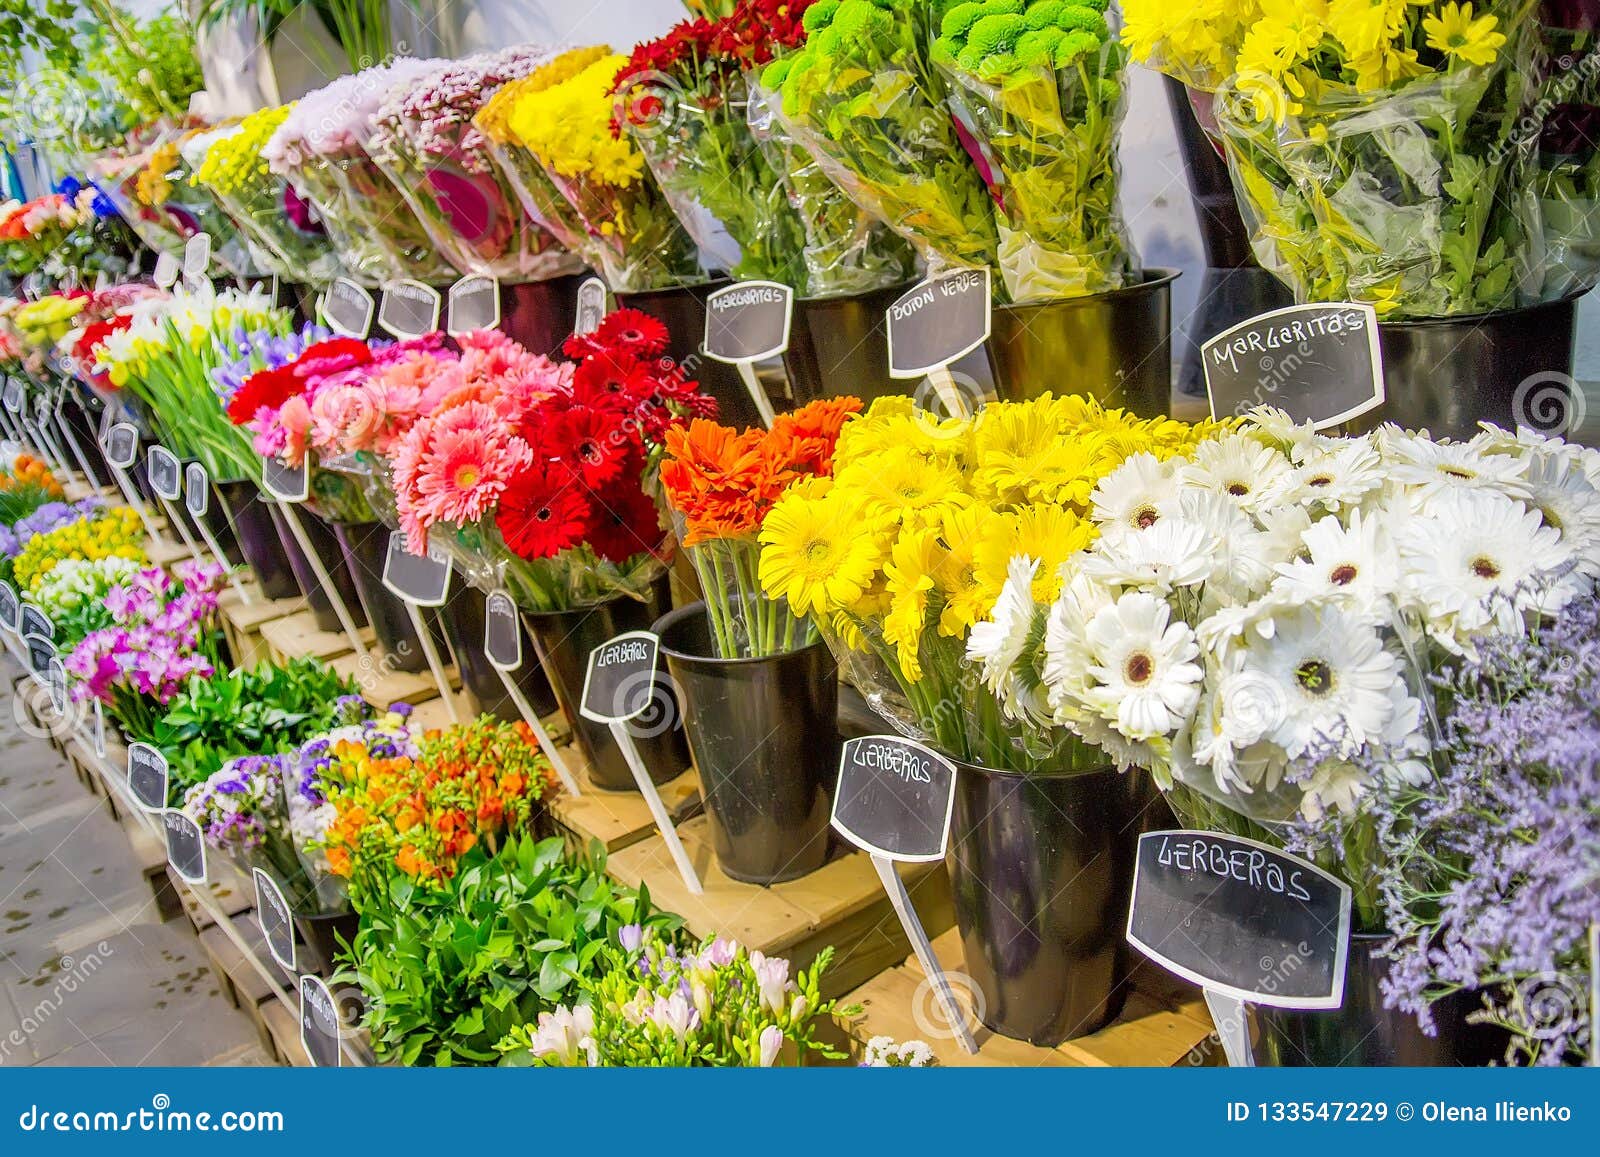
[838,928,1221,1067]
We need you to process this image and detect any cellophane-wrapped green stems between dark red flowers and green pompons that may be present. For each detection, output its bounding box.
[747,85,915,298]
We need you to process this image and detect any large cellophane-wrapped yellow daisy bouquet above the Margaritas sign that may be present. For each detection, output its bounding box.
[1122,0,1542,318]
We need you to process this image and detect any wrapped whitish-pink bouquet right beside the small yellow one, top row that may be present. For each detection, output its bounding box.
[261,56,453,285]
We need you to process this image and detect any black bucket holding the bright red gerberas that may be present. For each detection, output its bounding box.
[523,594,690,792]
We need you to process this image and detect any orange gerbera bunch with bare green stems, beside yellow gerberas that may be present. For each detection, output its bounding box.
[661,398,861,659]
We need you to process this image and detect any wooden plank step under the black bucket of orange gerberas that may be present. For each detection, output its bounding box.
[606,816,955,995]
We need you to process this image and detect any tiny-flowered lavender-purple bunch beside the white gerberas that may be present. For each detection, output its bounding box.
[1374,600,1600,1064]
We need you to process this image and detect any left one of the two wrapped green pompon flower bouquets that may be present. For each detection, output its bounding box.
[762,0,1005,293]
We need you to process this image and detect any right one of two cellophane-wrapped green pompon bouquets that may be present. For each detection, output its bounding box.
[931,0,1138,302]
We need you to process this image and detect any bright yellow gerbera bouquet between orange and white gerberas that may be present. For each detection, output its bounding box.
[760,394,1219,770]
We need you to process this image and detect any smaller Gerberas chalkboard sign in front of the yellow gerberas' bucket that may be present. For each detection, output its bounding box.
[834,735,955,863]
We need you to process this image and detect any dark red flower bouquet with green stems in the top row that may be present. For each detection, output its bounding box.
[616,0,810,285]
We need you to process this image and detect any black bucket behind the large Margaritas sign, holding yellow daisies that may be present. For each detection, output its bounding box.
[1350,294,1581,438]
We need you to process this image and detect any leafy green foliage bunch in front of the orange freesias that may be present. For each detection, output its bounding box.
[336,835,678,1066]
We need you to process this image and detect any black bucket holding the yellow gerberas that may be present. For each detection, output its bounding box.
[946,763,1154,1048]
